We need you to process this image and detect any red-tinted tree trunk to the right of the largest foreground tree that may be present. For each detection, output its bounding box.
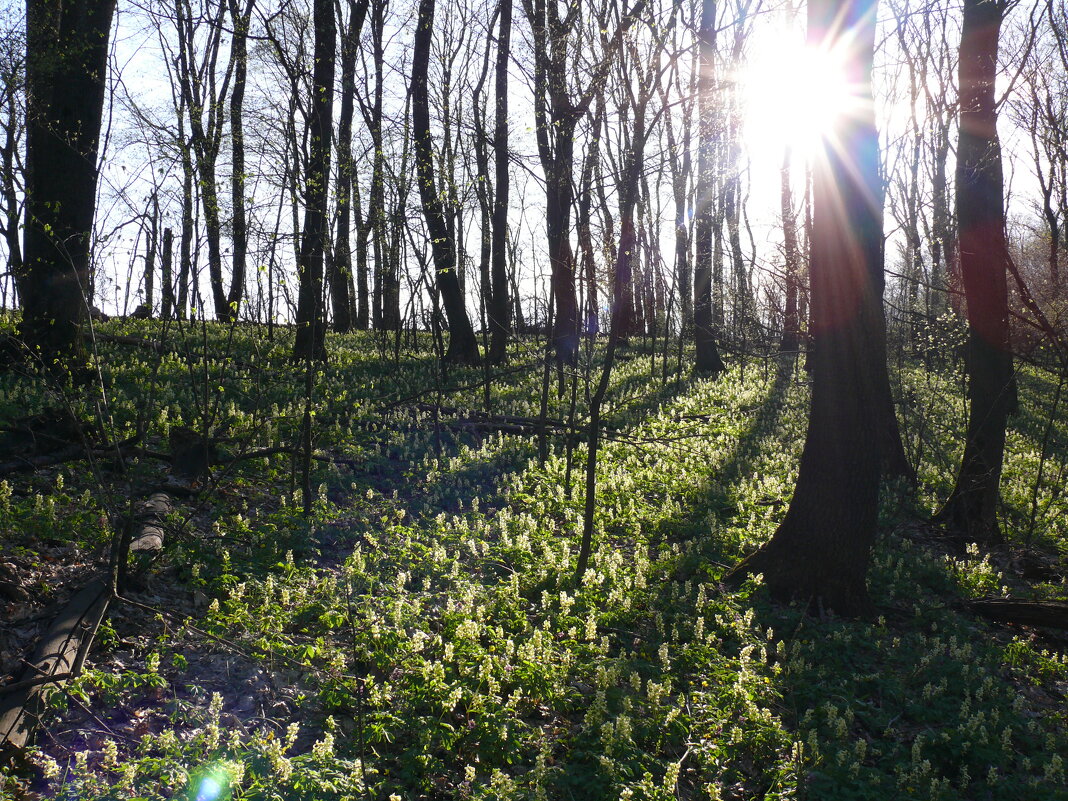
[937,0,1016,545]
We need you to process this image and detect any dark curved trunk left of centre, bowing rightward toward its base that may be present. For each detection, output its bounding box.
[411,0,478,364]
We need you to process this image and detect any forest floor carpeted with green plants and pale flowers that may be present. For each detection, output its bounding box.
[0,320,1068,801]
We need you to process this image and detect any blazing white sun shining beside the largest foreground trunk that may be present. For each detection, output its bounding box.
[738,28,865,162]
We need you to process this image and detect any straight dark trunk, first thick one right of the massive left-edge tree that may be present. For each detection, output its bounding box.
[293,0,337,360]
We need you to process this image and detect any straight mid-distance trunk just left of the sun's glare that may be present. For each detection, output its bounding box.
[693,0,726,374]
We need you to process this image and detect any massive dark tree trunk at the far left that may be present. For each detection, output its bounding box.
[17,0,115,365]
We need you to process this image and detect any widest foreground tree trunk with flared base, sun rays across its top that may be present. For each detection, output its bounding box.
[731,0,885,614]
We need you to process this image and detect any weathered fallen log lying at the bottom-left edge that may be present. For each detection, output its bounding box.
[0,579,111,750]
